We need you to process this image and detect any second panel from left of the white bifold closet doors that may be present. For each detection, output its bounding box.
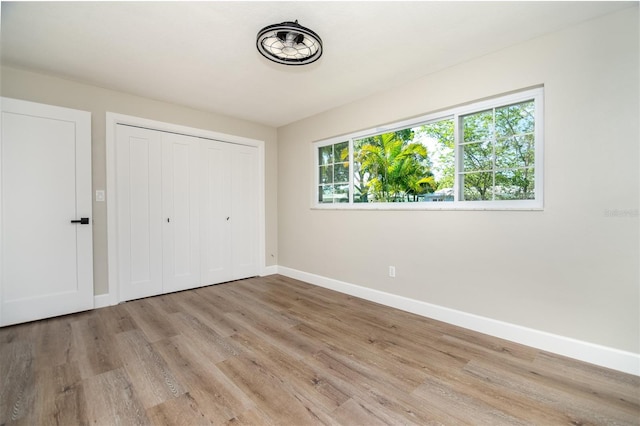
[162,133,200,293]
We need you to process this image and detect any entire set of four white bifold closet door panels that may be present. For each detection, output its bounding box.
[116,125,259,300]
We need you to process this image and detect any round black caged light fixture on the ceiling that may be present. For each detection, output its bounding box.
[256,20,322,65]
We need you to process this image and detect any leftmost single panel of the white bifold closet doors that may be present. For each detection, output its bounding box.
[116,125,166,301]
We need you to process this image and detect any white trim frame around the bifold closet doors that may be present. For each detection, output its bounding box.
[105,111,266,305]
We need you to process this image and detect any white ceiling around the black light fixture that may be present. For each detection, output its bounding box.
[1,1,637,127]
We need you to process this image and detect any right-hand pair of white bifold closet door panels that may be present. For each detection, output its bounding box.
[200,141,259,284]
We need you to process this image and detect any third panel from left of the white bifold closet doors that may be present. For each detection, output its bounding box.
[200,140,233,285]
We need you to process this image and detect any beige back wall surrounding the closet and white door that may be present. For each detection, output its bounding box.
[0,67,278,295]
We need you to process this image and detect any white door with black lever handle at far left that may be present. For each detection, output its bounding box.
[0,98,93,325]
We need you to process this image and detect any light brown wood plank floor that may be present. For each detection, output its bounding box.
[0,275,640,426]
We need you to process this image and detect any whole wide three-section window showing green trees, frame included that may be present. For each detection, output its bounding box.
[314,89,542,209]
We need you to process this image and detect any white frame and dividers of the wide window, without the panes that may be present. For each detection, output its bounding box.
[311,87,544,210]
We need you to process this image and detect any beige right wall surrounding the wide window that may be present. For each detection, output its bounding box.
[278,7,640,353]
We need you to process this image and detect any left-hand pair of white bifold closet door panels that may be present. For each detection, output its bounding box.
[116,125,200,300]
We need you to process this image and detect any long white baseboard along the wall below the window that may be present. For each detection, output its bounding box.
[276,266,640,376]
